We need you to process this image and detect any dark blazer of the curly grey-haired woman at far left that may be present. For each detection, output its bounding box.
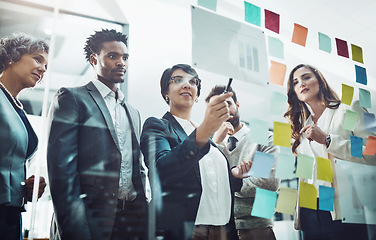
[0,89,38,208]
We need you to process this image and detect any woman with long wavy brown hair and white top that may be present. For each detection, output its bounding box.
[284,64,376,240]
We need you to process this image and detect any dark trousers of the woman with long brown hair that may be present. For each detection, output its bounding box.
[300,208,368,240]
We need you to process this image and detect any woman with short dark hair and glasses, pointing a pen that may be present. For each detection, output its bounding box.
[141,64,251,239]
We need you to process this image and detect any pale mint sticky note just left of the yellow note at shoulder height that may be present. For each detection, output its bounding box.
[248,118,269,146]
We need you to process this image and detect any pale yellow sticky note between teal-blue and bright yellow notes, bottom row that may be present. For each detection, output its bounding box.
[275,187,298,215]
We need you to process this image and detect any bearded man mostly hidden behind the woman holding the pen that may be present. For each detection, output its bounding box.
[206,85,280,240]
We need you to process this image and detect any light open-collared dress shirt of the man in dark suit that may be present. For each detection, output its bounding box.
[92,79,137,201]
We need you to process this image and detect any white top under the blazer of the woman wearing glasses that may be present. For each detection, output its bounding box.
[174,116,232,226]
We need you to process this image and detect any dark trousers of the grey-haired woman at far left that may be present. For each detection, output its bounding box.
[0,206,22,240]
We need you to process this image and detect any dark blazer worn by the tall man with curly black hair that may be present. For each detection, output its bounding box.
[47,82,146,239]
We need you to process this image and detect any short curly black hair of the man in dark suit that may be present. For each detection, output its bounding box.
[84,29,128,64]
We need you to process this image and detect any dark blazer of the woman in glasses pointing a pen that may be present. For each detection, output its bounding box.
[141,112,242,239]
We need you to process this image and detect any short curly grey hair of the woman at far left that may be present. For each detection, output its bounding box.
[0,33,49,73]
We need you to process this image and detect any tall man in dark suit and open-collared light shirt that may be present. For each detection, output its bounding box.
[47,29,147,240]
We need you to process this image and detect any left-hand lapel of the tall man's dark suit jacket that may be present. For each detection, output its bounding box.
[86,82,120,148]
